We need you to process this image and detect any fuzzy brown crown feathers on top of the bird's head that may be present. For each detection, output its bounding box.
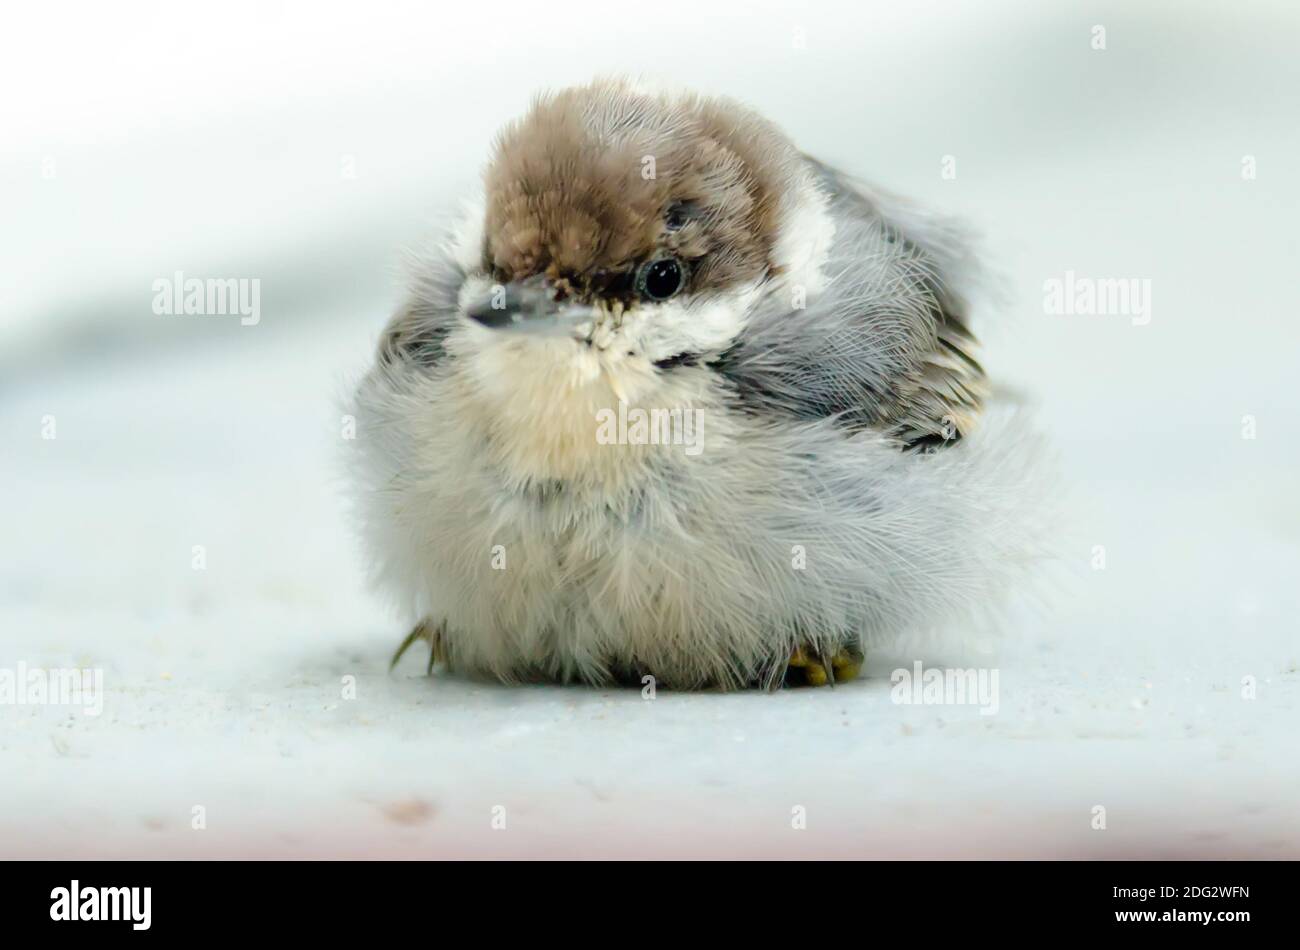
[484,82,797,304]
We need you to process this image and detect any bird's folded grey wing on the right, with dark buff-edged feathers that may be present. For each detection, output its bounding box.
[709,159,988,448]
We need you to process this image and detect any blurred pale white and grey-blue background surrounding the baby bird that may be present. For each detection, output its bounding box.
[0,0,1300,856]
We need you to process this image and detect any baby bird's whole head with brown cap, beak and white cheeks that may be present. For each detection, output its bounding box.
[449,81,820,399]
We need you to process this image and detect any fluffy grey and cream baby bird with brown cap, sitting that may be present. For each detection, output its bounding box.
[354,81,1034,689]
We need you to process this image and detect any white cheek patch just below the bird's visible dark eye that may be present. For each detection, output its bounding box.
[624,281,761,361]
